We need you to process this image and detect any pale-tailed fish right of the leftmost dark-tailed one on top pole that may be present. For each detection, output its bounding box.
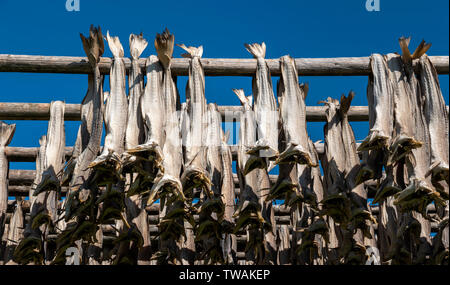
[89,31,128,182]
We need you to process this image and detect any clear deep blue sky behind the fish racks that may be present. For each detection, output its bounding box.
[0,0,449,169]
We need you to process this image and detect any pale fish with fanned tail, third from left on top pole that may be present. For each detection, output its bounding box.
[125,33,147,150]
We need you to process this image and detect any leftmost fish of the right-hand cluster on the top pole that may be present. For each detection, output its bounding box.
[358,54,394,151]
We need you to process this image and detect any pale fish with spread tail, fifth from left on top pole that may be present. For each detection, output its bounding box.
[178,44,213,197]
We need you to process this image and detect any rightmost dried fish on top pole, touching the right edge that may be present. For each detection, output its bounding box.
[419,54,449,185]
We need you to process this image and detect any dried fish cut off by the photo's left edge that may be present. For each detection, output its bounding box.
[0,121,16,238]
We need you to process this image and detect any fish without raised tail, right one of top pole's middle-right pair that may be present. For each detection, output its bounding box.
[275,55,317,166]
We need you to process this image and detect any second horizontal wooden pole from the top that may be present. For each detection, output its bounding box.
[0,102,369,122]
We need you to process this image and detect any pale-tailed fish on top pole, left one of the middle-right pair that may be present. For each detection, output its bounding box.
[244,43,279,175]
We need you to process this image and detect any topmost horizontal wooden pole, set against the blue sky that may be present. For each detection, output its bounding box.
[0,54,449,76]
